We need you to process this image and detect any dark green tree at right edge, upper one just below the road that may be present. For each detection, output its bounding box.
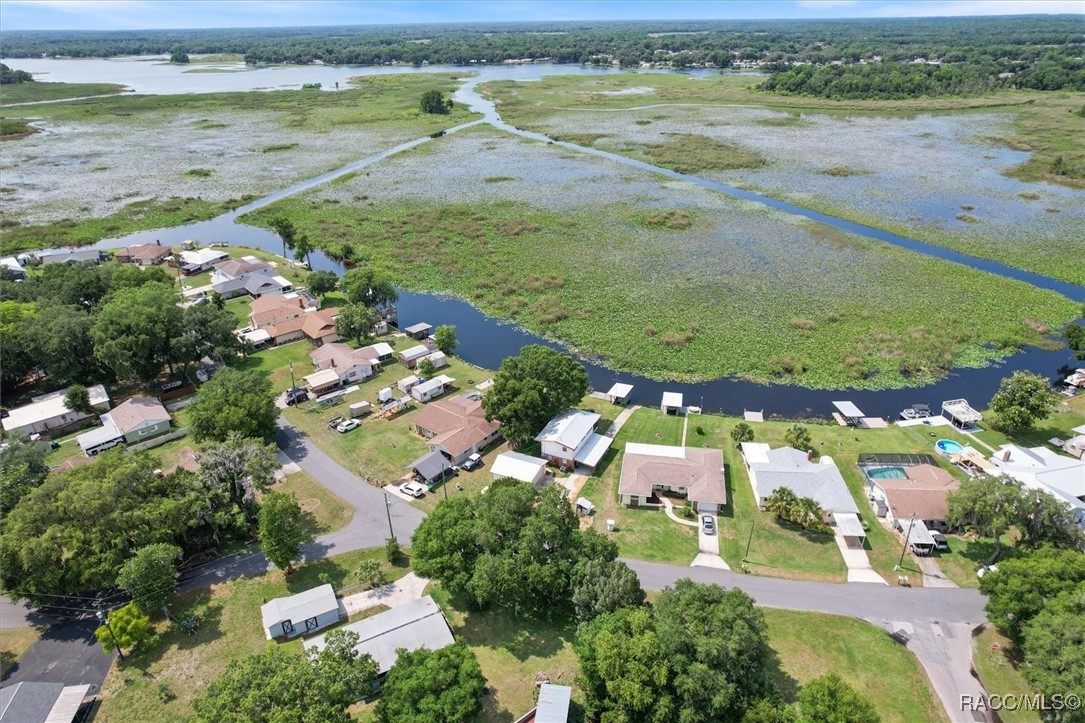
[980,547,1085,642]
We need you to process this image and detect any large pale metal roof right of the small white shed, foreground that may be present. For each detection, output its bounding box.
[305,595,456,673]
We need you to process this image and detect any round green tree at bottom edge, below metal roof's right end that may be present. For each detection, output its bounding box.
[376,642,486,723]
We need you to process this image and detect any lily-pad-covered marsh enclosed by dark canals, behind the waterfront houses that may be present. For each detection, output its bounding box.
[239,129,1080,389]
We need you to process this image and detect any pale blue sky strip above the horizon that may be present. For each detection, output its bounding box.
[0,0,1085,34]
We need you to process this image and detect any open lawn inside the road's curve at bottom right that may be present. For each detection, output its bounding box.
[765,609,946,723]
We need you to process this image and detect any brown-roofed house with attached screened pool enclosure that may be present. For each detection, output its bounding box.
[865,464,960,530]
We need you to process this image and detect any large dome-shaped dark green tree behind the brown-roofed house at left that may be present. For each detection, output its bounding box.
[91,283,182,384]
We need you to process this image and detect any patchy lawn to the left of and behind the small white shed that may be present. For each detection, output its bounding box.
[97,550,407,723]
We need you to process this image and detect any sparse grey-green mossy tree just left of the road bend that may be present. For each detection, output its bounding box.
[200,432,279,522]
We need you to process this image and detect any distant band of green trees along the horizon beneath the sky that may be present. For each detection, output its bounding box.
[3,15,1085,98]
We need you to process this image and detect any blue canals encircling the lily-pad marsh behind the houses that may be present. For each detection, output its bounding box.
[31,68,1085,417]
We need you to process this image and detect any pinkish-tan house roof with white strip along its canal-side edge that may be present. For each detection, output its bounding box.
[617,442,727,505]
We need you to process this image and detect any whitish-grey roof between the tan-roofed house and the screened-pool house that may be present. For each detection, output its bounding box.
[742,442,859,512]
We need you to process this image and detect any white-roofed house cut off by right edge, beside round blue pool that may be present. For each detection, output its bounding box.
[991,444,1085,528]
